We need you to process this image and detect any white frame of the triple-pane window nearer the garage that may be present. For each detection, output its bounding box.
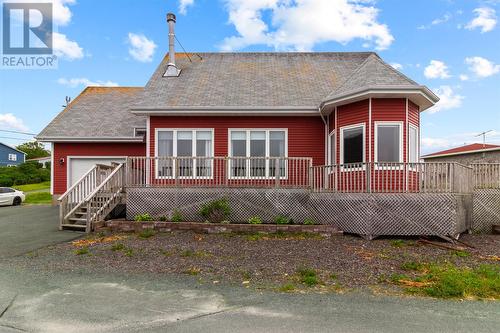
[155,128,215,179]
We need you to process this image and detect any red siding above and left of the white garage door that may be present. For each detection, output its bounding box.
[52,142,146,194]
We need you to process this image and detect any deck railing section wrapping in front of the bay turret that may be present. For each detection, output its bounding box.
[311,162,473,193]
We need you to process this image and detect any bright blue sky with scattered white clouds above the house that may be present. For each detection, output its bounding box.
[0,0,500,153]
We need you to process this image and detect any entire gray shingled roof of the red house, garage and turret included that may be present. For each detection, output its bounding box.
[38,52,437,141]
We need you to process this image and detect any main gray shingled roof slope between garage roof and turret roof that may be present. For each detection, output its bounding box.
[132,52,372,110]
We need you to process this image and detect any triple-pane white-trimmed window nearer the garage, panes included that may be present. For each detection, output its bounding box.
[155,128,214,178]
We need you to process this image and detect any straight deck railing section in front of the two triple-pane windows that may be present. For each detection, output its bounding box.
[126,157,312,188]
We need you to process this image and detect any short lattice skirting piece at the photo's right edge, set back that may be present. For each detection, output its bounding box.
[473,189,500,233]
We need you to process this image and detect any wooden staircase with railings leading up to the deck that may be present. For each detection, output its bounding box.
[59,164,125,233]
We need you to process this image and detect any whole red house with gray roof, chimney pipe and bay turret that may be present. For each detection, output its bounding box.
[38,14,476,237]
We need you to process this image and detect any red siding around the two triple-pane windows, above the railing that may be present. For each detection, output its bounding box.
[150,116,325,165]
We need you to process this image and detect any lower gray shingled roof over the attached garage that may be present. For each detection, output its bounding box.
[37,87,146,140]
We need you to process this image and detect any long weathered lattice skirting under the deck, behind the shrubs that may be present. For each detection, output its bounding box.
[127,188,472,237]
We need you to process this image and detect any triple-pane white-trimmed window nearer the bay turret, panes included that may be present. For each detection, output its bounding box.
[229,129,288,178]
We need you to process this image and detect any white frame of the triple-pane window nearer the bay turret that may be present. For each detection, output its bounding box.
[227,128,288,180]
